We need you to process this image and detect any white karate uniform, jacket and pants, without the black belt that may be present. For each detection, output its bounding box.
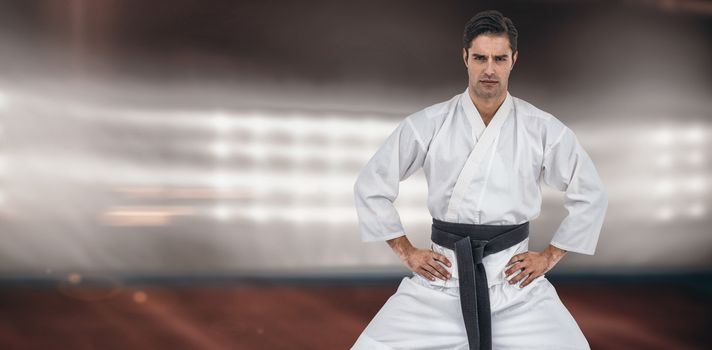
[353,90,608,349]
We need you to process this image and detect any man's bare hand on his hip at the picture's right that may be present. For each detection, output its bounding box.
[504,245,566,288]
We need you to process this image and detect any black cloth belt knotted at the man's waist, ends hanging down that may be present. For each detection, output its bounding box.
[430,219,529,350]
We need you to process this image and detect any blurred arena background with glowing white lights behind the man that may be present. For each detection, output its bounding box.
[0,0,712,349]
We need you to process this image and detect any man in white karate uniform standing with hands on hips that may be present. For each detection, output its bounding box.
[353,11,608,350]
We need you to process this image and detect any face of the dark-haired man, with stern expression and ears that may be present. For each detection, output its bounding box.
[462,34,517,99]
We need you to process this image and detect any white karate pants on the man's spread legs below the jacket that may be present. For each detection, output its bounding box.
[351,274,590,350]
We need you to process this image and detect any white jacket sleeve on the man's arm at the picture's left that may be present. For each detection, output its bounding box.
[354,116,426,242]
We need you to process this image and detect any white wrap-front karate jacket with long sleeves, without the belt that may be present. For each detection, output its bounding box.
[354,90,608,287]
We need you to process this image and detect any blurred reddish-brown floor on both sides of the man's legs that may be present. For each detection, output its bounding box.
[0,285,712,350]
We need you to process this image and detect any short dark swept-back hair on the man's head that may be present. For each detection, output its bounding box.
[462,10,519,54]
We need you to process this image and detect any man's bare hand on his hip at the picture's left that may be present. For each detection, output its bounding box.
[388,236,452,281]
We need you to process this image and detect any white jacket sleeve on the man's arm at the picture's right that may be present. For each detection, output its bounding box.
[543,126,608,255]
